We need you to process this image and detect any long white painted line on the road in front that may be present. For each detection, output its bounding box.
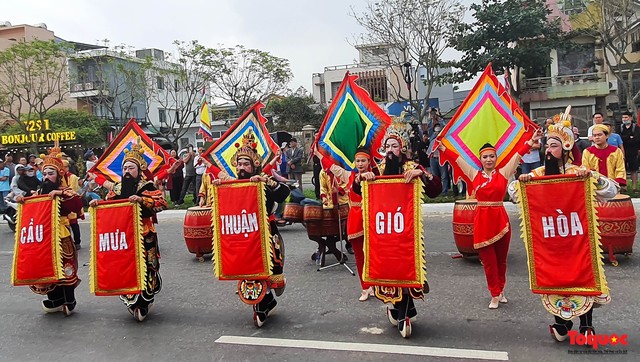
[215,336,509,361]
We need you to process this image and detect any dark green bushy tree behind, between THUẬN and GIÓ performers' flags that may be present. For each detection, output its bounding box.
[266,95,322,131]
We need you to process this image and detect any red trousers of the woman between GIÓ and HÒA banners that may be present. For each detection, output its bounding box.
[476,228,511,297]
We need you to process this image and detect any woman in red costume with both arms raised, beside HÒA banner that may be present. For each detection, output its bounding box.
[439,130,542,309]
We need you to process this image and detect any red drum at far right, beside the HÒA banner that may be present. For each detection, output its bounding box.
[596,195,636,266]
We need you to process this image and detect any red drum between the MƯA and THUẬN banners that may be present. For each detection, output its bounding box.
[183,207,213,261]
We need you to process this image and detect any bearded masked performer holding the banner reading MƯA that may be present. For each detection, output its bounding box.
[90,145,167,322]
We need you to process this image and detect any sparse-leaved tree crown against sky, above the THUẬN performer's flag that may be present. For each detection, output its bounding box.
[208,45,293,112]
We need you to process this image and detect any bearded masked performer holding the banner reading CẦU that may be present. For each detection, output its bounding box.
[16,146,82,315]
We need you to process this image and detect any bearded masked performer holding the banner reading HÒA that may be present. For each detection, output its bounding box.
[509,114,619,342]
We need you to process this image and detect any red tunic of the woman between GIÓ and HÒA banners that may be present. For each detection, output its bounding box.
[473,170,510,249]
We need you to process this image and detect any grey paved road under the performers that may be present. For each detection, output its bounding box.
[0,205,640,361]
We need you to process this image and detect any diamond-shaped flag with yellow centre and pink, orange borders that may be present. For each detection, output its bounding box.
[434,63,538,194]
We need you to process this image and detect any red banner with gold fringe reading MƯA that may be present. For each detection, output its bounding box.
[89,200,146,296]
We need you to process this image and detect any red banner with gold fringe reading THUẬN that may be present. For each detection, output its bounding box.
[211,181,273,280]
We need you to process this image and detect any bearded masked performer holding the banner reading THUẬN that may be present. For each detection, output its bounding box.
[213,140,290,328]
